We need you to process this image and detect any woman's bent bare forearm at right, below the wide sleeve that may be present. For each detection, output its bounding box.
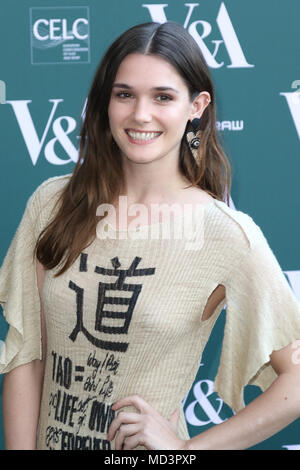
[186,341,300,450]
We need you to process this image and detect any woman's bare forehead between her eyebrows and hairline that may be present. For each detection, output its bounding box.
[115,54,187,90]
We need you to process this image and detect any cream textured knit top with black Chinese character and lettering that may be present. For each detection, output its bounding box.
[0,174,300,450]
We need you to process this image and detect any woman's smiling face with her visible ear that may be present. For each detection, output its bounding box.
[108,53,206,167]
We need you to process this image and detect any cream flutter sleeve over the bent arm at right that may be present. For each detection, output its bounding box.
[215,217,300,412]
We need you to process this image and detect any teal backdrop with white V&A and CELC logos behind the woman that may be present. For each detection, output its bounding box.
[0,0,300,450]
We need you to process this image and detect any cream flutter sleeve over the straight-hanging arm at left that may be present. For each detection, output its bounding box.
[0,193,42,374]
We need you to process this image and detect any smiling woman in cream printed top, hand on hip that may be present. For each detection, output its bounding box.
[0,22,300,450]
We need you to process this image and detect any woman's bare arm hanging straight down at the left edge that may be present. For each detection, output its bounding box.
[3,261,46,450]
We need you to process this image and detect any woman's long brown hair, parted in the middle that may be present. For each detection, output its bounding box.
[34,22,231,277]
